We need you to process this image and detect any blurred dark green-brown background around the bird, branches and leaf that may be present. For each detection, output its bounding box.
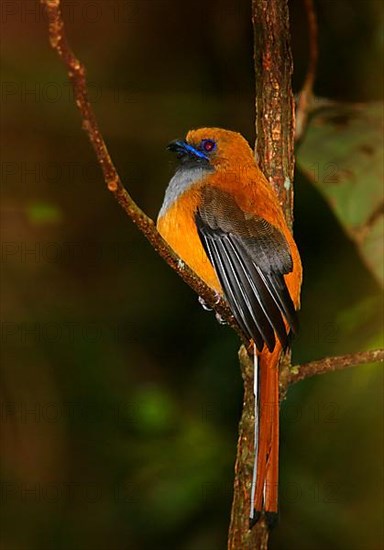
[0,0,383,550]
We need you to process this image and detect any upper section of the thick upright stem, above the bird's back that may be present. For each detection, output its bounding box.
[252,0,295,226]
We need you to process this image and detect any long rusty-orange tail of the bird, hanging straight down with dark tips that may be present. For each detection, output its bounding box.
[250,345,281,526]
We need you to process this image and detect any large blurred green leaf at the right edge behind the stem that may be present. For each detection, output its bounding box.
[297,100,384,284]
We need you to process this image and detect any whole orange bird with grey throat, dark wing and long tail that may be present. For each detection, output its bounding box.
[157,128,302,525]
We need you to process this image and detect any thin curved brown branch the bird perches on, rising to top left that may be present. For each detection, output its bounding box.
[41,0,246,342]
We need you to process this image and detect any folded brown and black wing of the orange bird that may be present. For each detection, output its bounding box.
[195,186,297,351]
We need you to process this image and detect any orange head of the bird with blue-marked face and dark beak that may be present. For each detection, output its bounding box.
[168,128,255,169]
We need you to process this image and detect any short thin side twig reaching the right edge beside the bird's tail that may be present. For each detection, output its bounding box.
[288,349,384,385]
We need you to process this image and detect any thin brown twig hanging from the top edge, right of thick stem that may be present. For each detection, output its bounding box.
[295,0,319,141]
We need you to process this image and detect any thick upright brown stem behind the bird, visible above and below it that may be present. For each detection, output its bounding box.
[228,0,294,550]
